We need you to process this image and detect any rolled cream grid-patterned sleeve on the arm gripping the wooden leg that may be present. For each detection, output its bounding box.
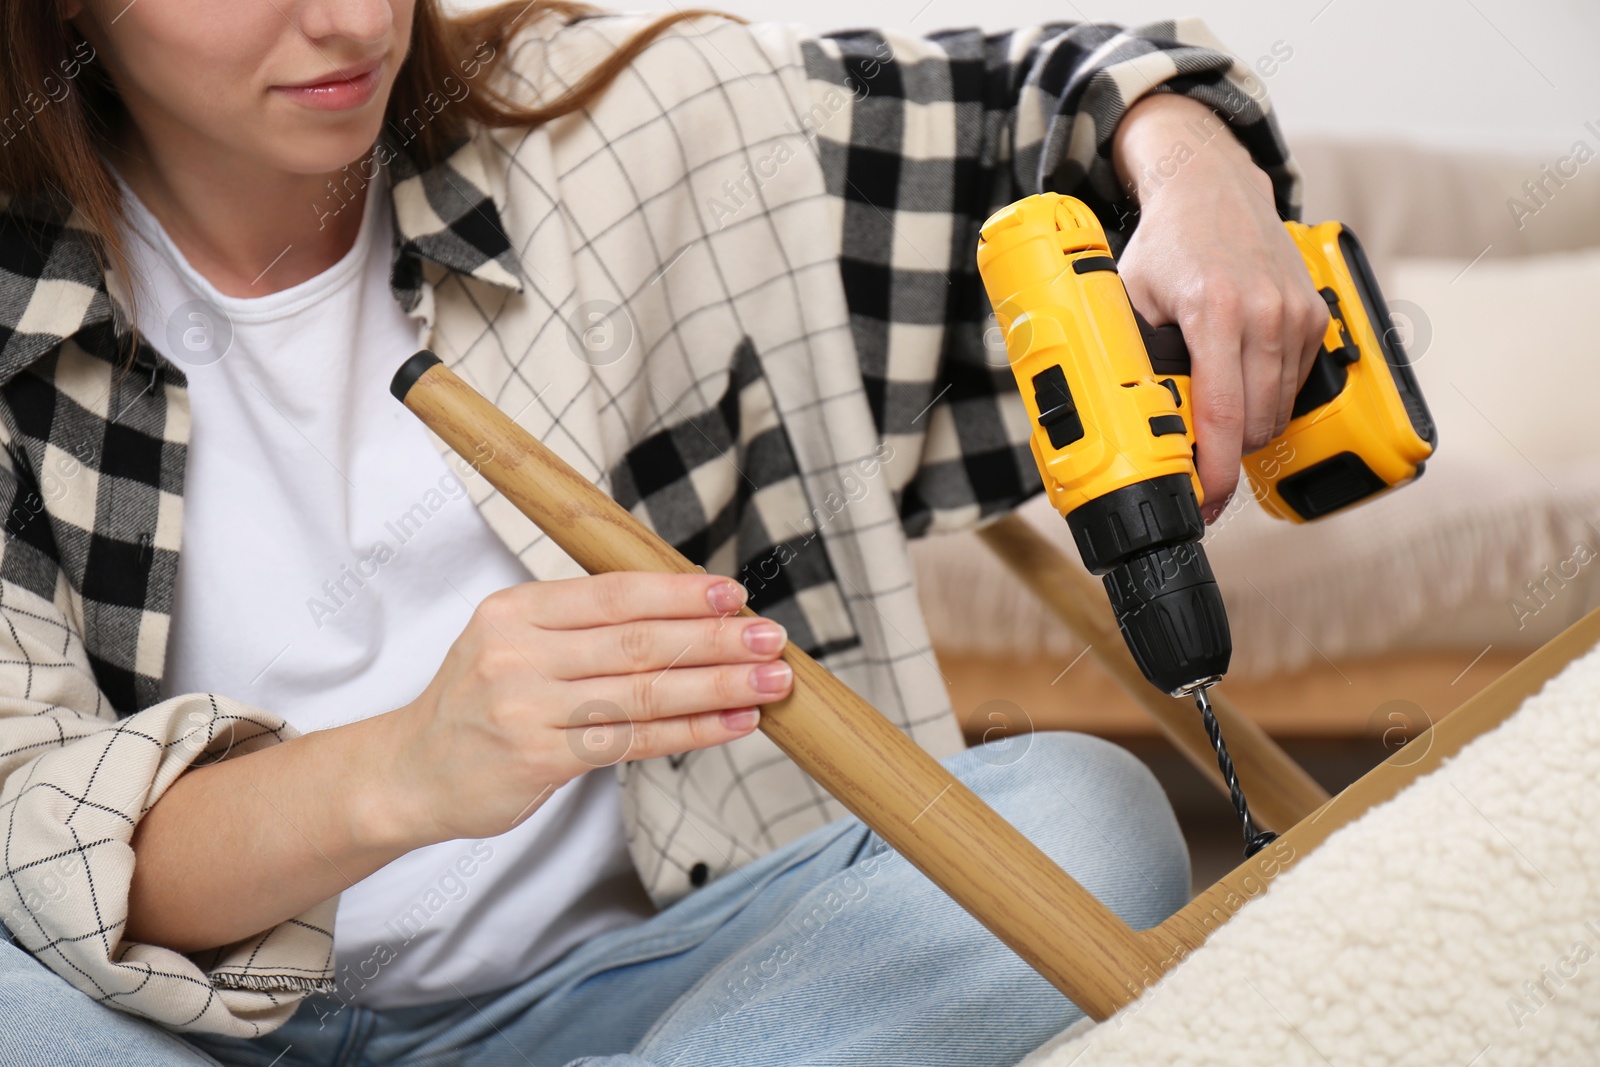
[0,450,338,1038]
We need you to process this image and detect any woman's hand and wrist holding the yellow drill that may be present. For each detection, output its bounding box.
[1112,93,1328,522]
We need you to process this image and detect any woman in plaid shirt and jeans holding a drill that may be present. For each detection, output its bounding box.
[0,0,1326,1064]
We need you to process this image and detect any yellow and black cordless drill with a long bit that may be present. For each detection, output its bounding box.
[978,194,1437,856]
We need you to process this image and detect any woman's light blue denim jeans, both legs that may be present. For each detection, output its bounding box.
[0,733,1189,1067]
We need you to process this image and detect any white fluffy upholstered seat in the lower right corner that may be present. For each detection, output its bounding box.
[1024,633,1600,1067]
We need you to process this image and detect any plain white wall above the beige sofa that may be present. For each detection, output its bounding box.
[595,0,1600,158]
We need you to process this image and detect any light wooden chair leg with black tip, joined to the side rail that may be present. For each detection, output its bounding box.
[390,352,1600,1019]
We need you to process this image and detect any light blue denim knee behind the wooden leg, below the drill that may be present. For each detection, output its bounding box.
[947,731,1189,928]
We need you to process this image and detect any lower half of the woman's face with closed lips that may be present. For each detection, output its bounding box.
[64,0,416,174]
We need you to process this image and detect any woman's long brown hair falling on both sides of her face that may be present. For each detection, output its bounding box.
[0,0,746,358]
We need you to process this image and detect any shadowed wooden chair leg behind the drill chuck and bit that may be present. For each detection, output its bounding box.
[978,514,1328,830]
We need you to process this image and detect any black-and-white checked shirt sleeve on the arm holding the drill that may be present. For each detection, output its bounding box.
[800,19,1299,536]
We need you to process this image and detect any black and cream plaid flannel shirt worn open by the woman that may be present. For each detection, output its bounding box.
[0,16,1298,1037]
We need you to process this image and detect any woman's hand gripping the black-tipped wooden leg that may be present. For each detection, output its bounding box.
[378,571,794,848]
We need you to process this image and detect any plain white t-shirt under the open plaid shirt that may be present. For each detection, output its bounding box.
[123,168,651,1008]
